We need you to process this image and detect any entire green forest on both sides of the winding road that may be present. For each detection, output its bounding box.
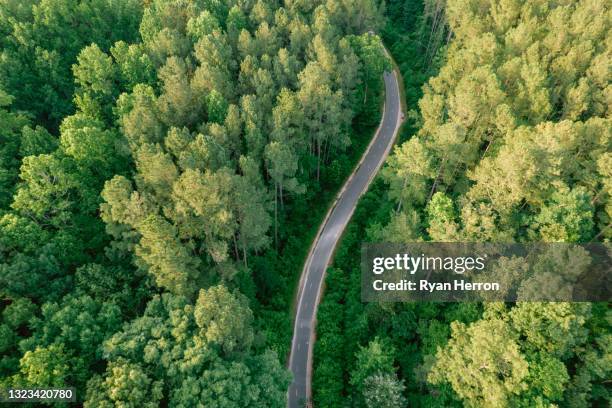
[0,0,612,408]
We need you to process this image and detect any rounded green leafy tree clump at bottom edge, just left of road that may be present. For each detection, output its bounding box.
[86,286,289,407]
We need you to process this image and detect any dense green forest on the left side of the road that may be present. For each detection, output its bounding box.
[0,0,386,407]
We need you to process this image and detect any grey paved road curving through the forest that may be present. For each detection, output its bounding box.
[287,55,403,408]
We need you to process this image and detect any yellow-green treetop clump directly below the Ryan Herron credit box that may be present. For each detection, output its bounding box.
[429,303,591,406]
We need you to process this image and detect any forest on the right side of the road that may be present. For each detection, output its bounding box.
[313,0,612,408]
